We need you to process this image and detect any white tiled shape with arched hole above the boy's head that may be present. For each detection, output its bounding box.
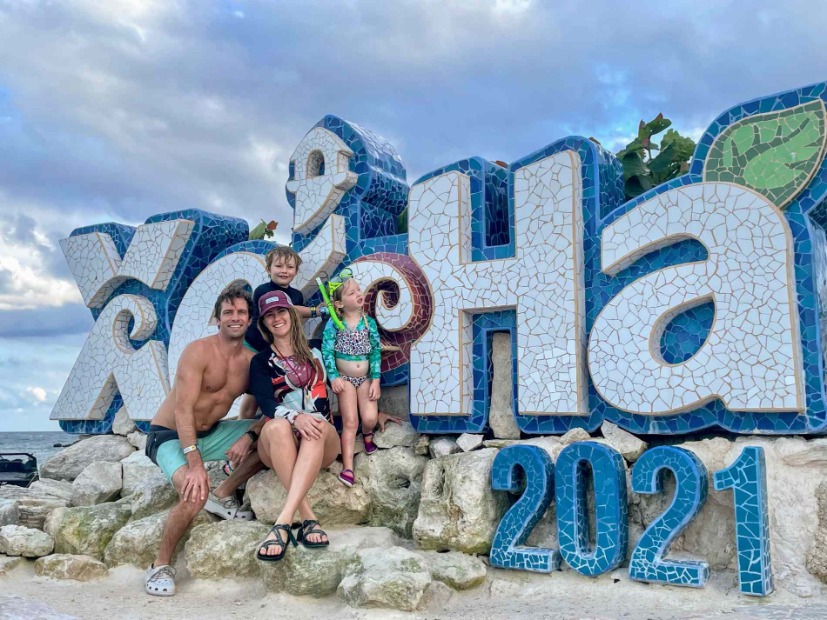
[287,127,359,234]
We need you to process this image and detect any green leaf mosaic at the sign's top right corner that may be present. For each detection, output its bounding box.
[704,100,827,207]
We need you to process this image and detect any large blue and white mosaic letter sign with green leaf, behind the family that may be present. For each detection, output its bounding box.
[52,84,827,436]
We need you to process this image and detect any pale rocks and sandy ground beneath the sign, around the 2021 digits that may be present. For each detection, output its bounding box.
[0,390,827,620]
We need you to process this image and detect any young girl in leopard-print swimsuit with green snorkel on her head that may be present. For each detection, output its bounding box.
[322,278,381,487]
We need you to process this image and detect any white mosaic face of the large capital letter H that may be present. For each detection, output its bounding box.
[409,151,588,416]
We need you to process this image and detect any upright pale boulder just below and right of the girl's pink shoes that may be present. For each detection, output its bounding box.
[357,447,428,538]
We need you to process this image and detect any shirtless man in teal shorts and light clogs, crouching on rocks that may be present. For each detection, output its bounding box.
[145,280,266,596]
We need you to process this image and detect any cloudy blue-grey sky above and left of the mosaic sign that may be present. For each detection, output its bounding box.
[0,0,827,431]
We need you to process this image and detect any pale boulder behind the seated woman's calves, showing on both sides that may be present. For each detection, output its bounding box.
[247,468,370,527]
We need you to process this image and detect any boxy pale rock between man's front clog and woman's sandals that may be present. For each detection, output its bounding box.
[184,521,269,579]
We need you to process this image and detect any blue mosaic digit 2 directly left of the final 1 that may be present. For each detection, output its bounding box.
[629,446,709,588]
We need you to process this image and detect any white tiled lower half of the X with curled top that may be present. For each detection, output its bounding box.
[51,295,170,420]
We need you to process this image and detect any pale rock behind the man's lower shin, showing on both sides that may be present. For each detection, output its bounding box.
[103,510,213,568]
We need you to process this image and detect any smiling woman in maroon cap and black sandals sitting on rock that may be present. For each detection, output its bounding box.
[250,291,339,562]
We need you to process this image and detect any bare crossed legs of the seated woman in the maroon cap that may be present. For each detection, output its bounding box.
[258,419,339,555]
